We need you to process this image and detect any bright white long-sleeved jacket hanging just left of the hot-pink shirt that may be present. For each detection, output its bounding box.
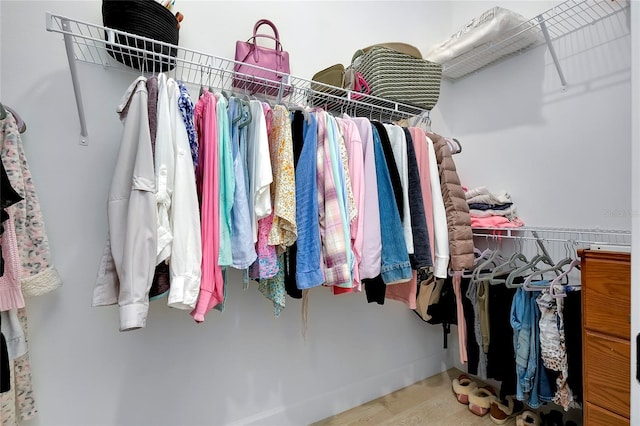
[167,78,202,309]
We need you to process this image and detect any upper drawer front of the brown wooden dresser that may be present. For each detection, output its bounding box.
[582,251,631,340]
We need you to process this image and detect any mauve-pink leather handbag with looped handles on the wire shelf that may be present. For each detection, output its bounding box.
[233,19,291,97]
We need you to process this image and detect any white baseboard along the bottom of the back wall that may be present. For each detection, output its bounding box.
[230,350,453,426]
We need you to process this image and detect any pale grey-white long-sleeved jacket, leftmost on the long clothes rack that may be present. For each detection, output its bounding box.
[93,77,157,331]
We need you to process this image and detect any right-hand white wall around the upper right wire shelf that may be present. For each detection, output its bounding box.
[434,1,631,230]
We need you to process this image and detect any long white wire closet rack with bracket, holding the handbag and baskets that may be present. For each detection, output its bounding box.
[46,12,429,145]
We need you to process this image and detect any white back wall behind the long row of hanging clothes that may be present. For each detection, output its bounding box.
[0,0,460,426]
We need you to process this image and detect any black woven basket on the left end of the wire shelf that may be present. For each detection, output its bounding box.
[102,0,179,72]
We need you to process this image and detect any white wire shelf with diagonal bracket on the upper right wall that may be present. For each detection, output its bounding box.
[442,0,630,85]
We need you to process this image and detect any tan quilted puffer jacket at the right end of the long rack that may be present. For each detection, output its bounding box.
[427,133,474,271]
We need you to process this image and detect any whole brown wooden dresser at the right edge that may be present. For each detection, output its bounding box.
[578,250,631,426]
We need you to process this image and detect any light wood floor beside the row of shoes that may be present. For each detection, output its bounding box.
[312,369,516,426]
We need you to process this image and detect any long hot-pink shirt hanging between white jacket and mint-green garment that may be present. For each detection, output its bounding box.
[191,90,224,322]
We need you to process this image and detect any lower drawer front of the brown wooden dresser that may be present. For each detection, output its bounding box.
[583,330,631,418]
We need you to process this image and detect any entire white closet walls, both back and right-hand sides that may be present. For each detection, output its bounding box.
[0,0,631,425]
